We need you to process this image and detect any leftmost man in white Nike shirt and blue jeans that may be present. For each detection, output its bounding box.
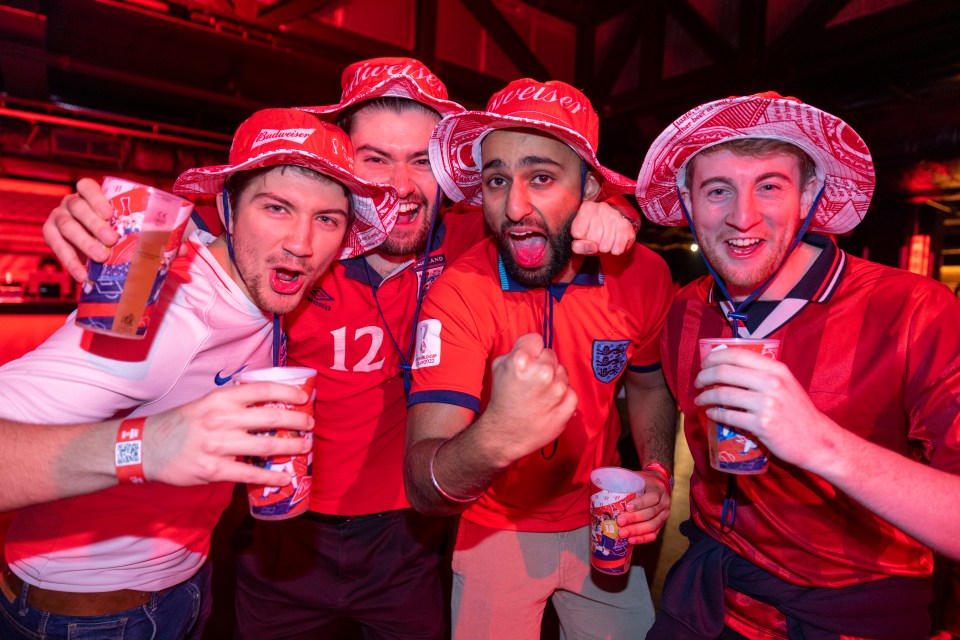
[0,109,398,639]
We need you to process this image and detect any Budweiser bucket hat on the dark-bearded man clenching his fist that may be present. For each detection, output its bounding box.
[430,78,635,205]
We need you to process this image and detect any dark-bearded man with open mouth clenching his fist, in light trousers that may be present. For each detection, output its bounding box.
[404,79,675,639]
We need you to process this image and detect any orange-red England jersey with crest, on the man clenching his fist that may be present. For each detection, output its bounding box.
[410,239,673,532]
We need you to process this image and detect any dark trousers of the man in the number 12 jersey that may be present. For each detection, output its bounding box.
[237,509,449,640]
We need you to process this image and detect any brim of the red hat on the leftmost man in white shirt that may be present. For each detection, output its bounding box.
[173,150,400,260]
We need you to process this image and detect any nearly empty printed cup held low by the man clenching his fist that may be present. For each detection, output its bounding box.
[590,467,646,575]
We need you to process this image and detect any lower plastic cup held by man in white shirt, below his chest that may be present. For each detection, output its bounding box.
[236,367,317,520]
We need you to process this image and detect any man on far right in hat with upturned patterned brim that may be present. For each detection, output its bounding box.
[637,93,960,640]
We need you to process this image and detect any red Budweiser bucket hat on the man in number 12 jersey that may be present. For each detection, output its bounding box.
[299,58,465,121]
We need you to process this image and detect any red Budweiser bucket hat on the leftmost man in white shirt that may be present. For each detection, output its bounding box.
[173,109,399,260]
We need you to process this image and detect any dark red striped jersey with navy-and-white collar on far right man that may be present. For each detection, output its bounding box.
[661,236,960,619]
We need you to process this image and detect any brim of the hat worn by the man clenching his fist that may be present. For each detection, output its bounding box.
[429,111,636,206]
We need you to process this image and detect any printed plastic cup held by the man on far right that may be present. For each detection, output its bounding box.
[700,338,780,474]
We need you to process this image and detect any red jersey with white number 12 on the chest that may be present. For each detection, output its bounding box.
[284,208,484,515]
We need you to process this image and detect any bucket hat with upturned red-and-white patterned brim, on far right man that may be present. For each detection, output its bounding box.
[637,91,876,234]
